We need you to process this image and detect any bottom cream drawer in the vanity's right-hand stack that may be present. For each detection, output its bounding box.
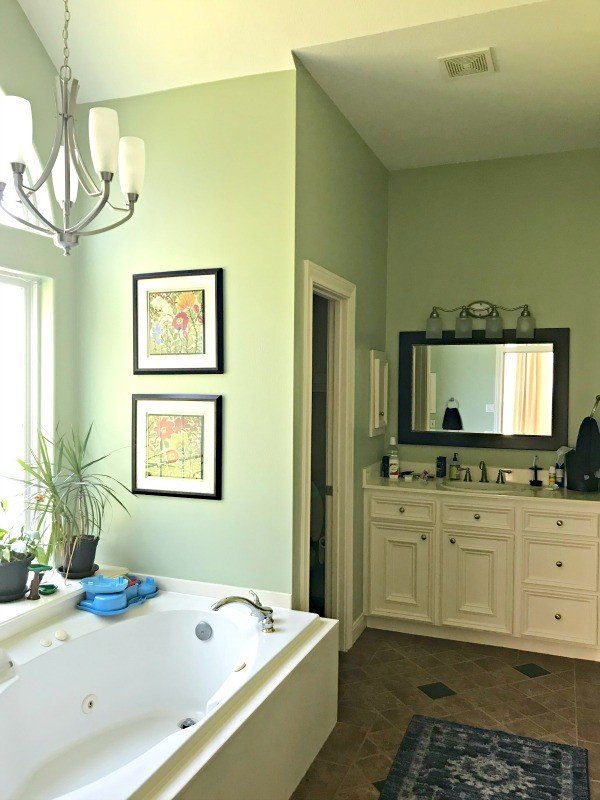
[521,591,598,645]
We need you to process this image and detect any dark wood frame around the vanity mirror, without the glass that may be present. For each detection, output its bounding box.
[398,328,571,451]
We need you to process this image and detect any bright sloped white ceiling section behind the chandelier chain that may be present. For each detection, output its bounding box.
[19,0,542,102]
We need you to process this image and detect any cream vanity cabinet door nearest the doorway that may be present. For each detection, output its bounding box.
[371,522,433,622]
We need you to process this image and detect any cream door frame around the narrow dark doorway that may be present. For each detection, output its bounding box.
[298,260,356,650]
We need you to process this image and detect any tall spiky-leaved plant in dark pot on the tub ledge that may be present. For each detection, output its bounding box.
[19,425,129,578]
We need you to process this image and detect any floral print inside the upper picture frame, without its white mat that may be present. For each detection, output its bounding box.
[148,289,205,356]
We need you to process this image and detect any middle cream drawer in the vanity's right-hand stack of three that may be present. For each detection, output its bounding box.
[523,536,598,592]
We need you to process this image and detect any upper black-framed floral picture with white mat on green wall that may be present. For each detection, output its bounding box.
[133,269,223,375]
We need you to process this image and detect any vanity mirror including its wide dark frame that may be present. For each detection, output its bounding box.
[398,328,569,450]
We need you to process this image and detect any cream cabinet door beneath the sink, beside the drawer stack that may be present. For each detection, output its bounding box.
[442,530,513,633]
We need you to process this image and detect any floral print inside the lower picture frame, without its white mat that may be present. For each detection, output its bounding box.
[146,414,204,480]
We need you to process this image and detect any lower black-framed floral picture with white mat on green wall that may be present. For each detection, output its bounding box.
[131,394,222,500]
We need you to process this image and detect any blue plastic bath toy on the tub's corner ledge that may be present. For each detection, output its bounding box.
[77,575,158,617]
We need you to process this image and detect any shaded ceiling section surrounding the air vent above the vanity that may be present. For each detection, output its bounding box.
[296,0,600,169]
